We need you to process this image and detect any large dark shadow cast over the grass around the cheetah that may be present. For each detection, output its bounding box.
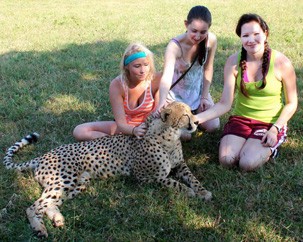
[0,38,303,241]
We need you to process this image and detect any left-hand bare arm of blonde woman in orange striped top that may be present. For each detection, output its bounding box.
[109,76,134,135]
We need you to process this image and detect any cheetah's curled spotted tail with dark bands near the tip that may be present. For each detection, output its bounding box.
[3,133,39,171]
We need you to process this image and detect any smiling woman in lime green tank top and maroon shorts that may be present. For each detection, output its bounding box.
[197,14,298,171]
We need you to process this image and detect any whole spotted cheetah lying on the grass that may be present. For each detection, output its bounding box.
[3,102,212,237]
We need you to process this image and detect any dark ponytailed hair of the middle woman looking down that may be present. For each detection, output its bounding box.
[187,5,212,65]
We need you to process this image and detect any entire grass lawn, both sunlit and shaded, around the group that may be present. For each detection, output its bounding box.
[0,0,303,241]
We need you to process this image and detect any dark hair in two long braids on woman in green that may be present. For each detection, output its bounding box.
[236,13,271,97]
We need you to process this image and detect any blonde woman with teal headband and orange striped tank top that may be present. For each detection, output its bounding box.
[73,43,161,141]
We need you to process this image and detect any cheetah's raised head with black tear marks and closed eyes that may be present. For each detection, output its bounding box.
[161,102,198,133]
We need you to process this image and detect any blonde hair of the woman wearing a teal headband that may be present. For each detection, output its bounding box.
[120,43,156,84]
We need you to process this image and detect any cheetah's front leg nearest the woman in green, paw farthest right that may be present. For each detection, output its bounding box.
[176,162,212,201]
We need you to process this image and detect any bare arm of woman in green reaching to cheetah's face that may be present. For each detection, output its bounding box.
[196,54,237,123]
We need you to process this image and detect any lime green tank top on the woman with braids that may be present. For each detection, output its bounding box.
[233,50,284,123]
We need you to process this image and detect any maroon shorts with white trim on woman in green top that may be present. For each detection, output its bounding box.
[221,116,287,156]
